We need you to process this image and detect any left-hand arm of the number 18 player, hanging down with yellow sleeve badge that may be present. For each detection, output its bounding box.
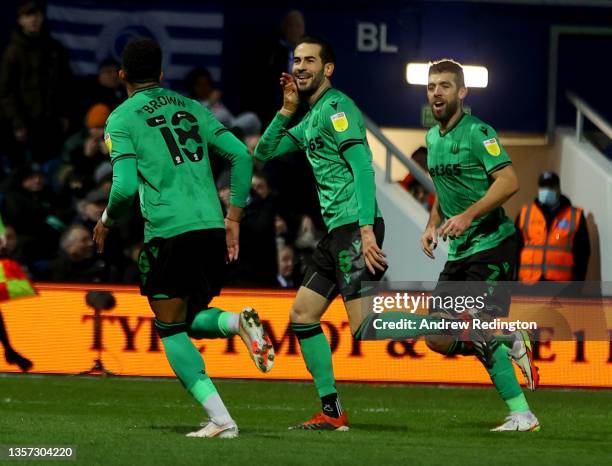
[94,114,138,252]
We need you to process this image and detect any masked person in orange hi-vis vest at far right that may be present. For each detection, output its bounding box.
[516,171,591,283]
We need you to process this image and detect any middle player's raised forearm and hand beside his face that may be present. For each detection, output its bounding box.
[254,73,304,162]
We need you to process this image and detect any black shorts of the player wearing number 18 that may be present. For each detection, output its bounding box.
[138,228,227,309]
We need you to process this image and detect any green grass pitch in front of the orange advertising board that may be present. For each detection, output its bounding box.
[0,375,612,466]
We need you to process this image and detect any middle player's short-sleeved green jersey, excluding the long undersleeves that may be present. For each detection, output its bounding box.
[287,88,382,231]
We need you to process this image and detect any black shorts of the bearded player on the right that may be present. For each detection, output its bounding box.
[430,235,518,317]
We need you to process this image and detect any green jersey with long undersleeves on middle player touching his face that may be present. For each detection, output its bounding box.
[255,88,381,231]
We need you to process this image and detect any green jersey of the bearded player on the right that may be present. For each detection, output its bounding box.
[426,113,515,260]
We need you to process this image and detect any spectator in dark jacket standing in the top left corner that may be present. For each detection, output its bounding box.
[0,1,72,165]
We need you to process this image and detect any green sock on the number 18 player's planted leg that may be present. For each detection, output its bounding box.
[155,319,217,404]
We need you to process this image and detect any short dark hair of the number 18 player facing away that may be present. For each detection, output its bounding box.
[121,38,162,84]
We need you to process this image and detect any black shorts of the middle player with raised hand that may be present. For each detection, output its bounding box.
[302,218,385,301]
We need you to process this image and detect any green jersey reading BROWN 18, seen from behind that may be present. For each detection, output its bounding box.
[104,86,252,241]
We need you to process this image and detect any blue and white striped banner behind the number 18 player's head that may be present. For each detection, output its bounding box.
[47,2,224,86]
